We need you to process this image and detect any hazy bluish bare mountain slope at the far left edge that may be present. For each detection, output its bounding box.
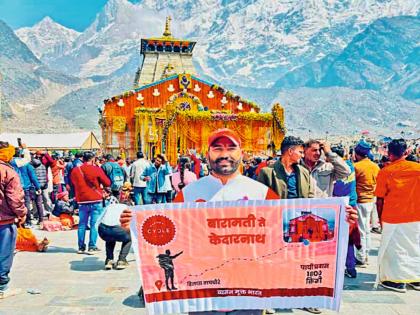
[0,20,89,131]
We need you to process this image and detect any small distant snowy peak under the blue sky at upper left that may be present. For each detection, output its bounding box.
[16,16,80,64]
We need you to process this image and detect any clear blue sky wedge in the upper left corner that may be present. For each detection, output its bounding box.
[0,0,138,31]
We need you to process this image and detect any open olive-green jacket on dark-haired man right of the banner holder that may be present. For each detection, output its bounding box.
[258,161,315,199]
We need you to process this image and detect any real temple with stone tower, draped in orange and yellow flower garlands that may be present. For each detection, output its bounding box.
[99,17,285,163]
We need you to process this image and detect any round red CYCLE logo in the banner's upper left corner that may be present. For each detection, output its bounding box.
[141,214,176,246]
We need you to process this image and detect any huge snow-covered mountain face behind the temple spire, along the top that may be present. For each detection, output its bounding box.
[16,0,420,87]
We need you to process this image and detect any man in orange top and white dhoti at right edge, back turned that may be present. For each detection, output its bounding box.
[375,139,420,292]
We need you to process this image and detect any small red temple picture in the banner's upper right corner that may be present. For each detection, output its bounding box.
[284,211,334,243]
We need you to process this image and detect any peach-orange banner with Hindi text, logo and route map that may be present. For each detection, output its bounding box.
[132,198,348,314]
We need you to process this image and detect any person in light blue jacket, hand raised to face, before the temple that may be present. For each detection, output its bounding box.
[140,154,171,204]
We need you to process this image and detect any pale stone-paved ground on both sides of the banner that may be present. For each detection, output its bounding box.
[0,231,420,315]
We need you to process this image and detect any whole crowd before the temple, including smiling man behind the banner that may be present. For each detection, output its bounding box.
[0,129,420,314]
